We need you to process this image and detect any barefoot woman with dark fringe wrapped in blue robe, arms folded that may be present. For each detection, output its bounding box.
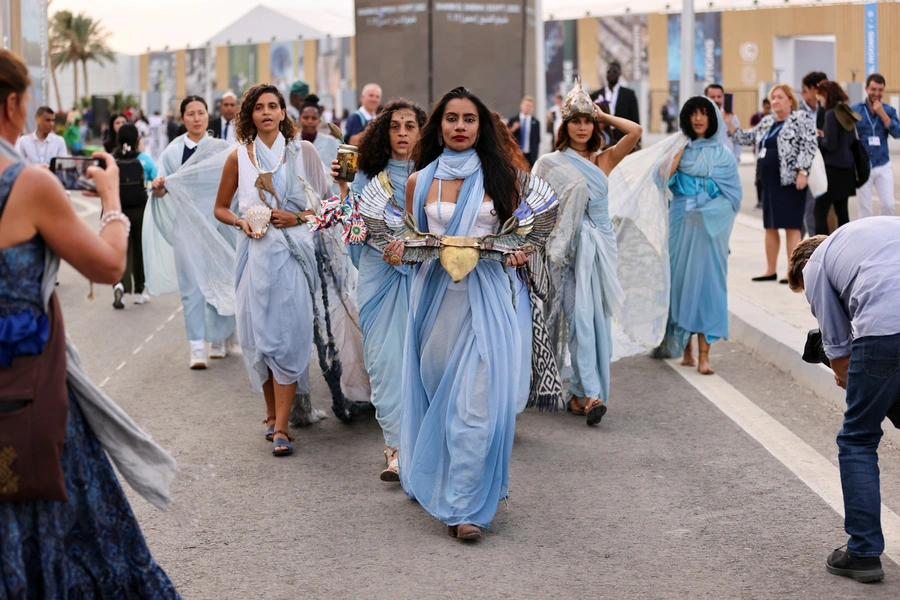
[666,96,742,375]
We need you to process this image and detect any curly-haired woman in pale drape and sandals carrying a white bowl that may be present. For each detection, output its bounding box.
[215,84,331,456]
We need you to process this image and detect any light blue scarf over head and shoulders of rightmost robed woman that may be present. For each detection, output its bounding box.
[678,96,743,212]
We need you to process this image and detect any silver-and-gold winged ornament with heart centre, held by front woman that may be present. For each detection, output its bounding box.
[359,171,559,283]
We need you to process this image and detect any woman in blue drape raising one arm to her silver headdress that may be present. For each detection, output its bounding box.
[533,82,642,425]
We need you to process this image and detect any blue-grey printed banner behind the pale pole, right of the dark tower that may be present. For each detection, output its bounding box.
[667,12,722,98]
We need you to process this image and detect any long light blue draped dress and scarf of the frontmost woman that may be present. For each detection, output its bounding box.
[400,149,522,528]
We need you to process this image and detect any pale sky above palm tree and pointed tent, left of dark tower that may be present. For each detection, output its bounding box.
[49,0,353,54]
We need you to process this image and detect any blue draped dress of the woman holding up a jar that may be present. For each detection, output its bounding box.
[350,159,412,448]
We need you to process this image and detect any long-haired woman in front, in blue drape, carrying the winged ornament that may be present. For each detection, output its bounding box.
[384,87,528,539]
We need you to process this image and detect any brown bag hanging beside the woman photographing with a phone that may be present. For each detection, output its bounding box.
[0,292,69,502]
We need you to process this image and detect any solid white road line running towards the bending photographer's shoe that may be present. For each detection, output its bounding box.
[666,358,900,564]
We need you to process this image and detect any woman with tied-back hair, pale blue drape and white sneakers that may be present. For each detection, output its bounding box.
[143,96,235,369]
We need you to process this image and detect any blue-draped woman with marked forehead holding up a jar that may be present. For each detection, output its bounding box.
[318,99,426,481]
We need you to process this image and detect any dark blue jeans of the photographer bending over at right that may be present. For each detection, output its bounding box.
[837,334,900,556]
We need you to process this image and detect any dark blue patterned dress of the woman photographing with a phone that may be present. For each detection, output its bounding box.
[0,164,179,600]
